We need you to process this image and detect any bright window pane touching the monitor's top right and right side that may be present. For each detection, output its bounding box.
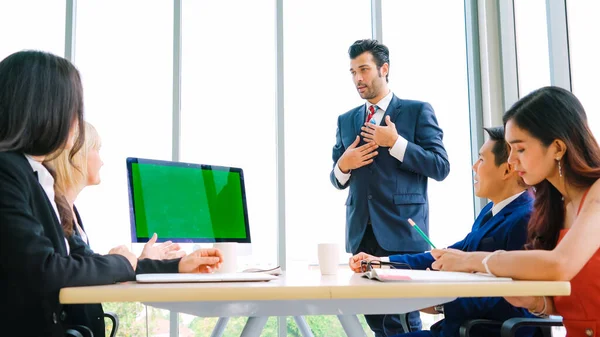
[181,0,277,265]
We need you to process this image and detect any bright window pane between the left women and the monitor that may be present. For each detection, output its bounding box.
[75,0,173,253]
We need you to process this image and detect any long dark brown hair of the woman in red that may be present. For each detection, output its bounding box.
[503,87,600,250]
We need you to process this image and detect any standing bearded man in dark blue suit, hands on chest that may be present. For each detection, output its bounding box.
[330,40,450,337]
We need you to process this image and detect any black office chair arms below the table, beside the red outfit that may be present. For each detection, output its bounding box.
[459,317,562,337]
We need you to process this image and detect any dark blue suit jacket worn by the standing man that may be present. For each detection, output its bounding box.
[330,96,450,252]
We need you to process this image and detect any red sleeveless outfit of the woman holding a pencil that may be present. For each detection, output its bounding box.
[554,190,600,337]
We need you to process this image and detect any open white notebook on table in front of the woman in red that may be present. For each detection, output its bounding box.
[363,269,512,282]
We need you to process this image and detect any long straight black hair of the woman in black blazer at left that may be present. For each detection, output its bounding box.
[0,50,85,236]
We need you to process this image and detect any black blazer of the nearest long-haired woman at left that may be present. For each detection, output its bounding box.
[0,152,179,337]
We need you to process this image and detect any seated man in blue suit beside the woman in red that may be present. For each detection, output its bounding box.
[350,127,533,337]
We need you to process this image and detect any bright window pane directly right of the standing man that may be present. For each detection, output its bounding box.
[383,0,474,247]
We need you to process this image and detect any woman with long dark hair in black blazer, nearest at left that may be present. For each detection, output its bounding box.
[0,51,222,337]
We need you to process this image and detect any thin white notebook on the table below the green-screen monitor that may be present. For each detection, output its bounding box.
[135,273,277,283]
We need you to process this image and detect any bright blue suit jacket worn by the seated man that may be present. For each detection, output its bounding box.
[390,191,533,336]
